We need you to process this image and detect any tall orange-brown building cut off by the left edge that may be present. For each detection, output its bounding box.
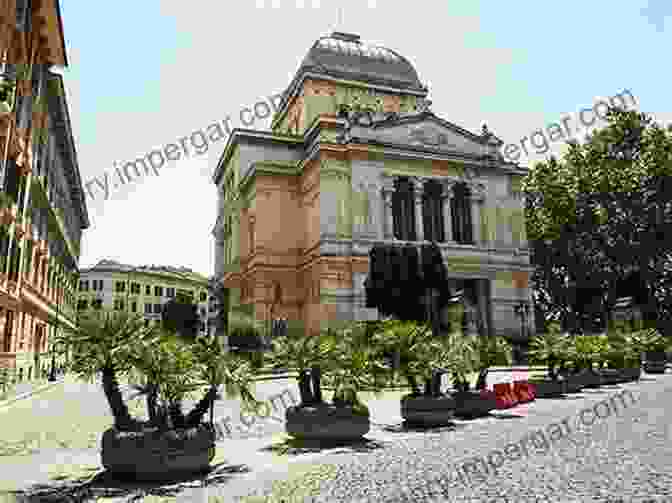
[0,0,89,380]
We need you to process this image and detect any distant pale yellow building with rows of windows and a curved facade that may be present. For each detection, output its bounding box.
[77,260,211,334]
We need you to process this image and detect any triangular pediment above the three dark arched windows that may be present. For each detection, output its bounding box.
[358,116,487,155]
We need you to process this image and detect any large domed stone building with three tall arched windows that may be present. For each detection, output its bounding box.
[213,32,533,342]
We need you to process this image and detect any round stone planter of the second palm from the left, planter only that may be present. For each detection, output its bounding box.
[285,403,371,441]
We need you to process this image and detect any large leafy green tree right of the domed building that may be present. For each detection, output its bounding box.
[523,108,672,333]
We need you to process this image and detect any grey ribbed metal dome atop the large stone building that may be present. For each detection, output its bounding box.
[298,32,427,92]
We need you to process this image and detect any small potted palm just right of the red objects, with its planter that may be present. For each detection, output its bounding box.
[529,325,571,398]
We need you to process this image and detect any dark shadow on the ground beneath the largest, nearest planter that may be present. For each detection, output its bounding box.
[14,463,251,503]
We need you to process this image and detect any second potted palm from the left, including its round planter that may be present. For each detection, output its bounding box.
[269,320,384,441]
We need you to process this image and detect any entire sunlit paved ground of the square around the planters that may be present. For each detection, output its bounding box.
[0,372,672,503]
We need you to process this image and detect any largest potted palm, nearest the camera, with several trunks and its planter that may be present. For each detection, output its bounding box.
[58,310,259,480]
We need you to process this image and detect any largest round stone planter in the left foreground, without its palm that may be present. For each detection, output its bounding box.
[101,424,215,480]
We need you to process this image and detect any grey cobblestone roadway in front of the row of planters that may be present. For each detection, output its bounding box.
[211,374,672,503]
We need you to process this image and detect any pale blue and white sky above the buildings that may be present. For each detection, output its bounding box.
[53,0,672,276]
